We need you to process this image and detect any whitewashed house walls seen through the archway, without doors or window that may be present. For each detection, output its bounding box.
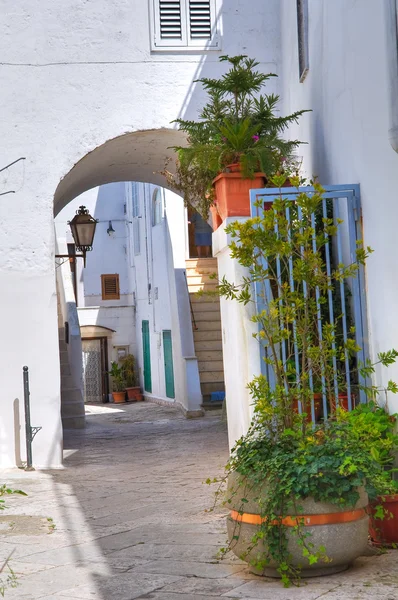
[55,182,197,410]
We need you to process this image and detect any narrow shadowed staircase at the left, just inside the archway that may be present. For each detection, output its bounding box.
[58,302,86,429]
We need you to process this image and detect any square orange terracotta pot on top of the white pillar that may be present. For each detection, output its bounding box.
[213,171,265,221]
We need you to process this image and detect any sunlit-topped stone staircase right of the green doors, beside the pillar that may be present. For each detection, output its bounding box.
[186,258,225,409]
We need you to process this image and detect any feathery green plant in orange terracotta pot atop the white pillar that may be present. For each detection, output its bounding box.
[163,55,306,228]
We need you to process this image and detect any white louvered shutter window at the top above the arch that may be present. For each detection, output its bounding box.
[149,0,221,50]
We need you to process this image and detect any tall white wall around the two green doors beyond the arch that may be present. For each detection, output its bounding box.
[126,183,188,408]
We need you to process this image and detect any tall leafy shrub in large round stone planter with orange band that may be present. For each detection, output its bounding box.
[210,176,398,585]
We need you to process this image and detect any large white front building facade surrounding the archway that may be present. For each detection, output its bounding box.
[0,0,398,467]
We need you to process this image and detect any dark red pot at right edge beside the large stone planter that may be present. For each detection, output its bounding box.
[369,494,398,546]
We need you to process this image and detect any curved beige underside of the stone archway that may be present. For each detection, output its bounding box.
[54,128,185,216]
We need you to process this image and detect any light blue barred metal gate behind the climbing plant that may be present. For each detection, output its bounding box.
[250,185,368,422]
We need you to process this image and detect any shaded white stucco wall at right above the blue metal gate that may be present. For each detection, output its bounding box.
[281,0,398,411]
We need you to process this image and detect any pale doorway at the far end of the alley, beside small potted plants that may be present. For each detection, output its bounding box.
[82,337,109,402]
